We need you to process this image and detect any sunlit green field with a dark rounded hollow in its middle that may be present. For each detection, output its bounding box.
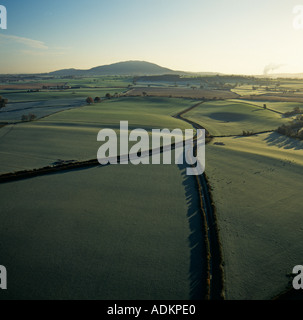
[185,100,286,136]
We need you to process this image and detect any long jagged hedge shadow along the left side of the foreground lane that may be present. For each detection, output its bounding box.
[179,165,207,300]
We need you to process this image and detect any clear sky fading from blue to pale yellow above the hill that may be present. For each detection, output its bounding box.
[0,0,303,75]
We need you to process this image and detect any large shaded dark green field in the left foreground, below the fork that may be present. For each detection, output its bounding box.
[0,161,202,300]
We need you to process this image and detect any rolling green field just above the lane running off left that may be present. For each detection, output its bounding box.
[0,98,195,173]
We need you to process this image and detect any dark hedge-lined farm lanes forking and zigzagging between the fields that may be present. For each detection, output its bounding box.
[0,102,224,300]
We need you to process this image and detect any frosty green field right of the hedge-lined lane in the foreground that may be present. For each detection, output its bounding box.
[206,133,303,300]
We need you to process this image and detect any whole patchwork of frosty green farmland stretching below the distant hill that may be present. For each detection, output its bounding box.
[0,76,303,300]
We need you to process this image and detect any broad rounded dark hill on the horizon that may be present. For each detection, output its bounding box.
[49,61,180,76]
